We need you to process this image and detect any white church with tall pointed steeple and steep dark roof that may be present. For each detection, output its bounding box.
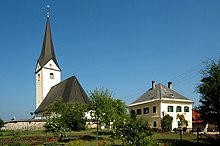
[34,14,90,118]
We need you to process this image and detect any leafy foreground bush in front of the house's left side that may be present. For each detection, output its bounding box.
[112,112,151,146]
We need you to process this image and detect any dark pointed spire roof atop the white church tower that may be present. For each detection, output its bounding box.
[37,17,60,69]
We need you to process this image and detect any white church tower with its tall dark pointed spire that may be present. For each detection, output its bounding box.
[35,14,61,109]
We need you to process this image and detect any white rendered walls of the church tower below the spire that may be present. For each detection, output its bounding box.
[35,59,61,109]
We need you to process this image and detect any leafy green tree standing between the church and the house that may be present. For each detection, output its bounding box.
[90,88,127,138]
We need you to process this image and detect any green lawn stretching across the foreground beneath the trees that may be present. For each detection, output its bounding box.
[0,129,219,146]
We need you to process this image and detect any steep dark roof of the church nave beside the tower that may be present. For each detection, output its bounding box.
[35,76,91,114]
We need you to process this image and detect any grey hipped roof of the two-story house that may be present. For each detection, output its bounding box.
[130,84,191,105]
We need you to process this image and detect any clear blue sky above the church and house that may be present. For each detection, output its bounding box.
[0,0,220,120]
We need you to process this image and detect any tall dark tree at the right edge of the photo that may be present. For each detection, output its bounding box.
[197,60,220,131]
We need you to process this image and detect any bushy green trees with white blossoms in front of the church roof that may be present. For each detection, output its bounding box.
[44,98,87,135]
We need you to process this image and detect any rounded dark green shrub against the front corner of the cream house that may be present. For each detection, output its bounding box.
[161,115,173,132]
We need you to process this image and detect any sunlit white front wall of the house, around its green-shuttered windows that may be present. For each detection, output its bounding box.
[161,102,192,129]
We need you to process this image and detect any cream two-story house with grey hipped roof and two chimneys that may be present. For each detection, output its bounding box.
[129,81,193,129]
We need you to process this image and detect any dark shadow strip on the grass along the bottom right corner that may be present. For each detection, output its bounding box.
[157,139,220,146]
